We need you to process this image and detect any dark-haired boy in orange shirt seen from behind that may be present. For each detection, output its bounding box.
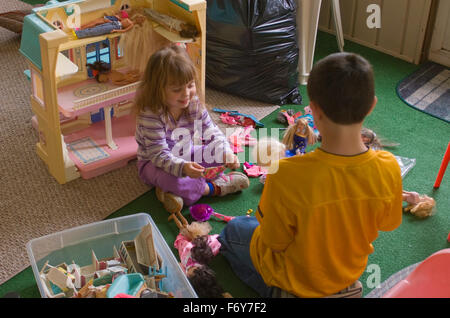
[219,53,402,297]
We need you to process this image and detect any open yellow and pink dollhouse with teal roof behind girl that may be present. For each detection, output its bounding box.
[20,0,206,184]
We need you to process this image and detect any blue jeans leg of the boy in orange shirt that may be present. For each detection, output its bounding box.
[218,216,272,297]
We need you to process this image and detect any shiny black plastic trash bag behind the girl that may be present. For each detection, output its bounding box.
[206,0,302,105]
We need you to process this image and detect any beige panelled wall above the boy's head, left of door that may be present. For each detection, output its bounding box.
[319,0,431,64]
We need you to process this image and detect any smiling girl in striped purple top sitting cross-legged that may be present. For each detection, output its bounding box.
[135,45,249,213]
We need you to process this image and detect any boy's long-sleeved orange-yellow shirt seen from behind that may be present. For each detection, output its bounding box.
[250,149,402,297]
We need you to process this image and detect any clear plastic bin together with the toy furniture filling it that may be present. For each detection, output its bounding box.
[26,213,193,298]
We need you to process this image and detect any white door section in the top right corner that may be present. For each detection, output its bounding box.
[428,0,450,67]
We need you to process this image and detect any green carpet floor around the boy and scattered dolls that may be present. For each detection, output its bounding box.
[0,32,450,297]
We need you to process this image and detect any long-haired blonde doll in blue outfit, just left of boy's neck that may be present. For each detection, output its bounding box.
[282,118,317,157]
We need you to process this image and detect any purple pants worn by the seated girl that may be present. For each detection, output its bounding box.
[137,161,206,206]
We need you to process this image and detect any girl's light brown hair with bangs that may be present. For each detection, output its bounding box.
[134,44,201,115]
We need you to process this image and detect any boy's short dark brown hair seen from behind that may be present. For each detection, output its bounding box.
[307,53,375,125]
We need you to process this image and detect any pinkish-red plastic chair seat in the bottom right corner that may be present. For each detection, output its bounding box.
[383,248,450,298]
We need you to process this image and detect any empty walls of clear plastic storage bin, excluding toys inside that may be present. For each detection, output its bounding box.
[26,213,197,298]
